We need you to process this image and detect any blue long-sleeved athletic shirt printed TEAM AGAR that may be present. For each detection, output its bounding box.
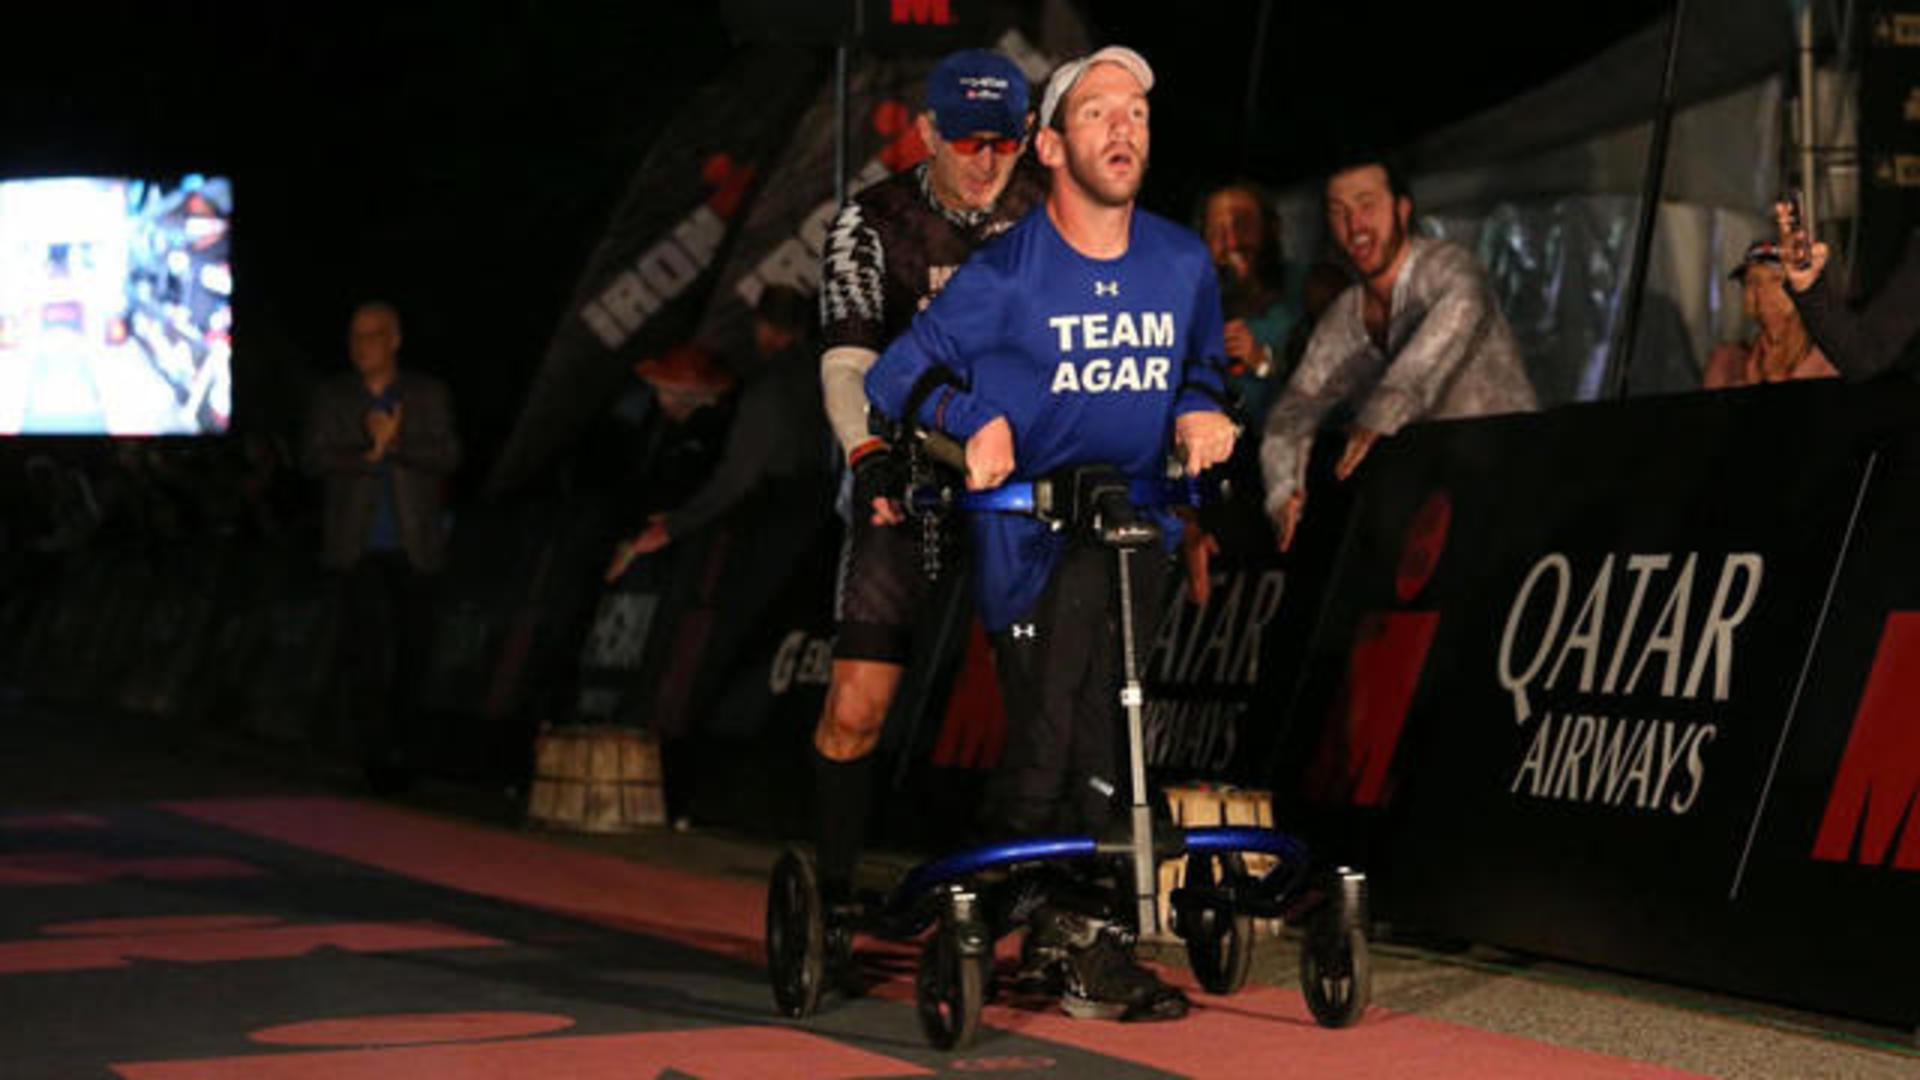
[866,204,1227,630]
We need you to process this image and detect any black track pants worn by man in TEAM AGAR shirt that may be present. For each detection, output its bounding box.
[987,542,1171,834]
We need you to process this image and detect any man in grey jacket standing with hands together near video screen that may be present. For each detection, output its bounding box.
[301,304,461,792]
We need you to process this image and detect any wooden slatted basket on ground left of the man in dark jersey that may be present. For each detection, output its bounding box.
[526,724,666,832]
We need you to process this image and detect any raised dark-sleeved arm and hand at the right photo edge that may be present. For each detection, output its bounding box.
[1774,202,1920,379]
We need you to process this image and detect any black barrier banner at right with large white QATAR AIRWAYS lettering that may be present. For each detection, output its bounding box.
[1288,382,1920,1022]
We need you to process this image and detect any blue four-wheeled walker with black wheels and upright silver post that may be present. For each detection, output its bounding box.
[766,467,1371,1049]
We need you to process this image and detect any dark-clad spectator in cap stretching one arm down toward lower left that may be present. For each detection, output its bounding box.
[607,284,831,580]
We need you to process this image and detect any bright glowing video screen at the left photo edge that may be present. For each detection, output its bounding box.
[0,175,234,434]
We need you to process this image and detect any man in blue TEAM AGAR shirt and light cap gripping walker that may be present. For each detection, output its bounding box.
[866,46,1235,1019]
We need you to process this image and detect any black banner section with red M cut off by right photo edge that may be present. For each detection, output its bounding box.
[1726,422,1920,1028]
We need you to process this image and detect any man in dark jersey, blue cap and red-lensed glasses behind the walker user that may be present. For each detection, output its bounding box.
[814,50,1046,903]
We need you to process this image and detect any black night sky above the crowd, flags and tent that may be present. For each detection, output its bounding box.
[0,0,1667,488]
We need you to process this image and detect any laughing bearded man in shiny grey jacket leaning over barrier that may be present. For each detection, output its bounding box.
[1260,160,1538,552]
